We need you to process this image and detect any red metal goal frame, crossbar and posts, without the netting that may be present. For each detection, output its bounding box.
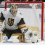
[5,1,44,40]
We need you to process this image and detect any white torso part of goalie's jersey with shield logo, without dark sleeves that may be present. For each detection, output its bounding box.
[3,11,22,30]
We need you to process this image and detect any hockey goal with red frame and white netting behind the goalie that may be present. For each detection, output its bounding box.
[0,1,44,40]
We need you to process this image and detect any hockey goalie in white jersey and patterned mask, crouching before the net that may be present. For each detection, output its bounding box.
[0,5,38,43]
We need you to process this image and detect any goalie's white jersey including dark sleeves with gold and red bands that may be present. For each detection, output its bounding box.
[0,11,26,32]
